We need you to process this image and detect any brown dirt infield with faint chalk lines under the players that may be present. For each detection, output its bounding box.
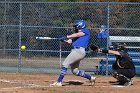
[0,73,140,93]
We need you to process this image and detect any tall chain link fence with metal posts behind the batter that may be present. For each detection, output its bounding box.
[0,0,140,73]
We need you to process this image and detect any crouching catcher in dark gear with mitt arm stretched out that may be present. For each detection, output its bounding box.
[90,43,136,86]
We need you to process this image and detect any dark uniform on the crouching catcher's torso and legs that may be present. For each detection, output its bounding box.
[112,50,136,85]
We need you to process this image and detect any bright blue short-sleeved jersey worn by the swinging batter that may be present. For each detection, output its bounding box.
[72,29,90,48]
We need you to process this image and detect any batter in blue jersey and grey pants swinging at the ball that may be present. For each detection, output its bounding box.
[51,20,95,86]
